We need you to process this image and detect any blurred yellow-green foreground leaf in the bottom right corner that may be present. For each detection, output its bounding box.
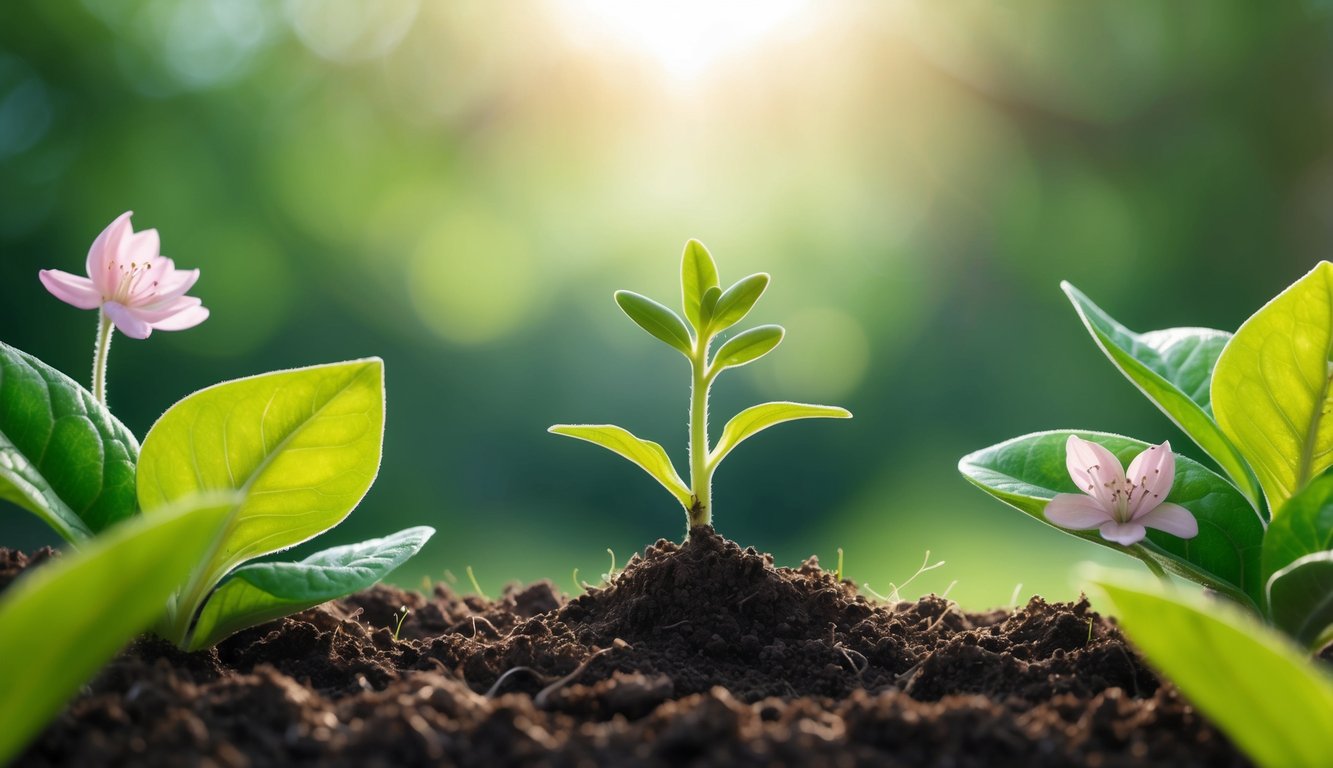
[1093,575,1333,768]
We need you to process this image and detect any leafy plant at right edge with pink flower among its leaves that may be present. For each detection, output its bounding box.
[958,261,1333,648]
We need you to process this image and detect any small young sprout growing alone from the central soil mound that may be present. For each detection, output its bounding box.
[549,240,852,528]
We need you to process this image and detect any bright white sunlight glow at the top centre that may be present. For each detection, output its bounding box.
[557,0,810,80]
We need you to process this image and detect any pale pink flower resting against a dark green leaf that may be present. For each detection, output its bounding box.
[1045,435,1198,547]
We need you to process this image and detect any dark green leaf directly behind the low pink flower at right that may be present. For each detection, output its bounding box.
[958,429,1264,607]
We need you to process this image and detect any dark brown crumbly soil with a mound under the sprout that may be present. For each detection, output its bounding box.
[0,528,1249,768]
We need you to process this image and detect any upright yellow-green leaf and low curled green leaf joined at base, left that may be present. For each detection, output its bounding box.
[139,359,431,648]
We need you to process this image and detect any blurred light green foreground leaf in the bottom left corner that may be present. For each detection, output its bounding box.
[0,495,235,765]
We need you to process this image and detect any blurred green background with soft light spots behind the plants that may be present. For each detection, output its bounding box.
[0,0,1333,608]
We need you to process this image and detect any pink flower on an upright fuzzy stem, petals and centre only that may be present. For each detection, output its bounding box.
[39,211,208,339]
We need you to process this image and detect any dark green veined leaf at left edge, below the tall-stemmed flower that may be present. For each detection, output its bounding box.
[0,343,139,544]
